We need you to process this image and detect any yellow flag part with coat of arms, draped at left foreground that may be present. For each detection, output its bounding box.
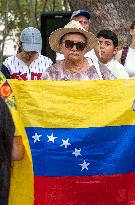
[0,73,34,205]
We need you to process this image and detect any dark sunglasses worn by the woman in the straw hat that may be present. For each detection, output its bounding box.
[62,40,86,51]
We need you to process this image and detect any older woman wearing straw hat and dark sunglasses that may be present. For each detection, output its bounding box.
[42,20,115,80]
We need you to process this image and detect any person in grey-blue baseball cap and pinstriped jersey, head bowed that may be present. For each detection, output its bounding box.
[1,27,53,80]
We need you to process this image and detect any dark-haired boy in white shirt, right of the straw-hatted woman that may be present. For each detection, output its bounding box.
[97,30,129,79]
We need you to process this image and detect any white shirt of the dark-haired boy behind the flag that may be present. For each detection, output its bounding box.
[105,59,129,79]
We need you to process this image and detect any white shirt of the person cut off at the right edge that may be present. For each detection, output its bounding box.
[124,47,135,78]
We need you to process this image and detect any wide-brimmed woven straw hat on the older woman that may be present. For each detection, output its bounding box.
[49,20,98,53]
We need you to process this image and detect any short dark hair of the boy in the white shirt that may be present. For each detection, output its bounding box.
[97,30,118,47]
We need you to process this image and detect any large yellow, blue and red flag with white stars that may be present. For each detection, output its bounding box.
[10,80,135,205]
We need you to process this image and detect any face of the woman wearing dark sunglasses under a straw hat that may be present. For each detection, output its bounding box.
[60,33,86,61]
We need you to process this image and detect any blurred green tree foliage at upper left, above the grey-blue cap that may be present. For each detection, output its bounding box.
[0,0,69,61]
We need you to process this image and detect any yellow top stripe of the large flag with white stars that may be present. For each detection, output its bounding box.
[10,80,135,128]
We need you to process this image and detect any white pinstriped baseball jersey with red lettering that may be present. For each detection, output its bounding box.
[1,54,53,80]
